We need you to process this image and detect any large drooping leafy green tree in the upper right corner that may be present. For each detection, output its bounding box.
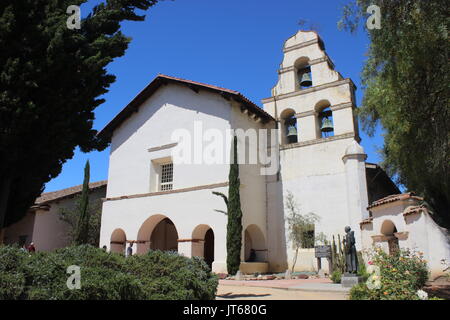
[340,0,450,228]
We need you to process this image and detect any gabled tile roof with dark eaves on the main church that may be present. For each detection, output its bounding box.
[98,74,275,139]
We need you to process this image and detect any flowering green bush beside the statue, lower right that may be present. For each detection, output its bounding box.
[350,248,428,300]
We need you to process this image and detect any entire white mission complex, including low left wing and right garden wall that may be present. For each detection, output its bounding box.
[0,31,450,279]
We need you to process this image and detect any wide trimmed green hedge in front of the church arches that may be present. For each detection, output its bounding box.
[0,245,218,300]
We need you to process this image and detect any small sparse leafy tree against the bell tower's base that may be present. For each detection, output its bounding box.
[285,191,326,272]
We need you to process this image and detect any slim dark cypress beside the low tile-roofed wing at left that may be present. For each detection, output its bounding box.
[75,160,90,245]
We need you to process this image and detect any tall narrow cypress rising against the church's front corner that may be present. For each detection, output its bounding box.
[227,136,242,274]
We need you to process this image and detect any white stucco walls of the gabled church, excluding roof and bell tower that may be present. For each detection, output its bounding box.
[100,84,267,272]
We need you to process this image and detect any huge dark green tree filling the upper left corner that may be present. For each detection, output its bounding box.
[0,0,161,229]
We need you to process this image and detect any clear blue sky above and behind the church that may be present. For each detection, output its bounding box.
[45,0,383,191]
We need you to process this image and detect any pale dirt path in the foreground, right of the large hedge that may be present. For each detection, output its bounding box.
[216,285,347,300]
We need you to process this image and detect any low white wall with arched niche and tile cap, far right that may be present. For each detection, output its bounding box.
[360,193,450,279]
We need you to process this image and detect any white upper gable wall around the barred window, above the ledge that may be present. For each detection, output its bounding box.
[107,84,231,197]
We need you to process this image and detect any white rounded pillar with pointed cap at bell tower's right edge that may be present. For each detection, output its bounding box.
[342,140,369,250]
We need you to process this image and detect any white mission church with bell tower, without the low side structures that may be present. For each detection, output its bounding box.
[100,31,399,273]
